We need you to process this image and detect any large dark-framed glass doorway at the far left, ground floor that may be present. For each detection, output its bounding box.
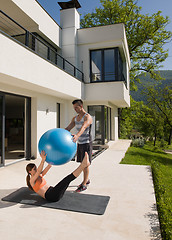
[0,93,31,165]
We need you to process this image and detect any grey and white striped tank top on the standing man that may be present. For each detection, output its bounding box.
[75,113,92,144]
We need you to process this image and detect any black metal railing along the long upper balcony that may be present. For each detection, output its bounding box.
[0,10,84,82]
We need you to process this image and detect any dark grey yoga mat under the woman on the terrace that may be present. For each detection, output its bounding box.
[2,187,110,215]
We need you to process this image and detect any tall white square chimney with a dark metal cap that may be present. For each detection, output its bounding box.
[58,0,81,67]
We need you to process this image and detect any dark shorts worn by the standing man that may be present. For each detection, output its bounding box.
[76,142,92,163]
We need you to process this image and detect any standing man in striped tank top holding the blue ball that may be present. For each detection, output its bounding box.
[65,99,93,192]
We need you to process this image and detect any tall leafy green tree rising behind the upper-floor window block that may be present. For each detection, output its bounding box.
[81,0,172,88]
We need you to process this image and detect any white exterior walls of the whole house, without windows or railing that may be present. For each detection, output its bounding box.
[0,0,130,164]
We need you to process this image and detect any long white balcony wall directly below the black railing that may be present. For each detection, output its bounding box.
[0,33,83,99]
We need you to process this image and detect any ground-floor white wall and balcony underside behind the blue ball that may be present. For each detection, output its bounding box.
[0,81,75,157]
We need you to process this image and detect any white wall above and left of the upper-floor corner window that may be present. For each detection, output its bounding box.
[78,24,130,82]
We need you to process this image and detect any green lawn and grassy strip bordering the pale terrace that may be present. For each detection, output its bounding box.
[121,143,172,240]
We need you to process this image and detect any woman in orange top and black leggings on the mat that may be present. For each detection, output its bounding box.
[26,151,90,202]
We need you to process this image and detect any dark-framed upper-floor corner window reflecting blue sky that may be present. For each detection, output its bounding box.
[90,48,125,82]
